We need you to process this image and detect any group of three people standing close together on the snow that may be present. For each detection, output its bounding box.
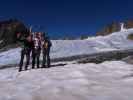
[18,32,52,72]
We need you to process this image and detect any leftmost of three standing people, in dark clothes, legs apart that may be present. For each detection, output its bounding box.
[19,35,34,72]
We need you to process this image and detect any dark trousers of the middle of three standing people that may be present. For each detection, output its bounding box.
[32,49,41,68]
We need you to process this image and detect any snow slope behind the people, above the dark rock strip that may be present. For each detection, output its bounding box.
[0,29,133,65]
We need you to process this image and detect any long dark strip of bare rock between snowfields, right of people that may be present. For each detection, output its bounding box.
[51,49,133,64]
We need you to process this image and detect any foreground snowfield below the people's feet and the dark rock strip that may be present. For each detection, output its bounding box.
[0,61,133,100]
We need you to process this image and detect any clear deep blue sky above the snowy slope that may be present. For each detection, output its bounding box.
[0,0,133,37]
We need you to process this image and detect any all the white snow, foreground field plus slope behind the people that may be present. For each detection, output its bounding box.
[0,29,133,100]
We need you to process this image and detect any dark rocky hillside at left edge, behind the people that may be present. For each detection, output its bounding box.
[0,19,29,49]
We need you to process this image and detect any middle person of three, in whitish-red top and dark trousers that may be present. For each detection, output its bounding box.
[32,33,42,69]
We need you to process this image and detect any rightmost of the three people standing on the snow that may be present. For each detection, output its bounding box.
[42,37,52,68]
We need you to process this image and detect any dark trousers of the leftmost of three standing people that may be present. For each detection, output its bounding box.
[19,48,31,71]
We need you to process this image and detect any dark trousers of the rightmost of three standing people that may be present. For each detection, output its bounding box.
[42,48,50,67]
